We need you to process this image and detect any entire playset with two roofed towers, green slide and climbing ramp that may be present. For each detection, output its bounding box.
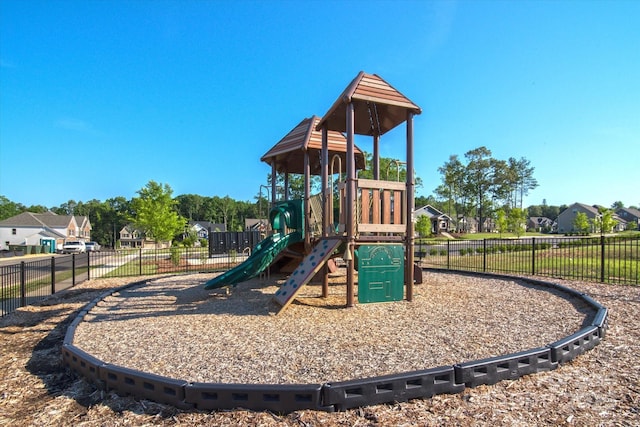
[205,72,421,308]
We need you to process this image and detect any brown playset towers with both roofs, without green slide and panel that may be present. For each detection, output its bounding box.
[261,72,421,307]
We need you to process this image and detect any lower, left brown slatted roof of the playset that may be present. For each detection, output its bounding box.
[260,116,365,175]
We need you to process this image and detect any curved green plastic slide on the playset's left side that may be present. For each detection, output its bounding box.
[204,231,303,289]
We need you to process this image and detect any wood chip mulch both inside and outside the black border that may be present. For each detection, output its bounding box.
[0,272,640,426]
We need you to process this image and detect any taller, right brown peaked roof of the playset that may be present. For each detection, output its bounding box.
[317,71,422,136]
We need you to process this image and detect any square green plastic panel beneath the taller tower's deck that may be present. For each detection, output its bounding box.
[358,245,404,303]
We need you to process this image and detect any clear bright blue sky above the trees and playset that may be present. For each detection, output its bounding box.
[0,0,640,207]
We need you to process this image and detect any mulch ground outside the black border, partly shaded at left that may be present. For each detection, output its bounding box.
[0,273,640,426]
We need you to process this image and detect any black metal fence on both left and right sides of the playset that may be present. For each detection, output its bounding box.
[0,236,640,316]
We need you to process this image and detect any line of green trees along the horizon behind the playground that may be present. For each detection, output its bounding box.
[0,146,636,246]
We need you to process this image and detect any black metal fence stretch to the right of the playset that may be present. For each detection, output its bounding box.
[415,236,640,285]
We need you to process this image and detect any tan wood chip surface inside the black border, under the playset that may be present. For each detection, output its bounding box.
[73,269,594,384]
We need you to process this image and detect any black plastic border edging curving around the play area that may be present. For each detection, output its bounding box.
[62,272,608,413]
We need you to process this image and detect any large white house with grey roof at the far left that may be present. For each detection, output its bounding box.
[0,211,91,250]
